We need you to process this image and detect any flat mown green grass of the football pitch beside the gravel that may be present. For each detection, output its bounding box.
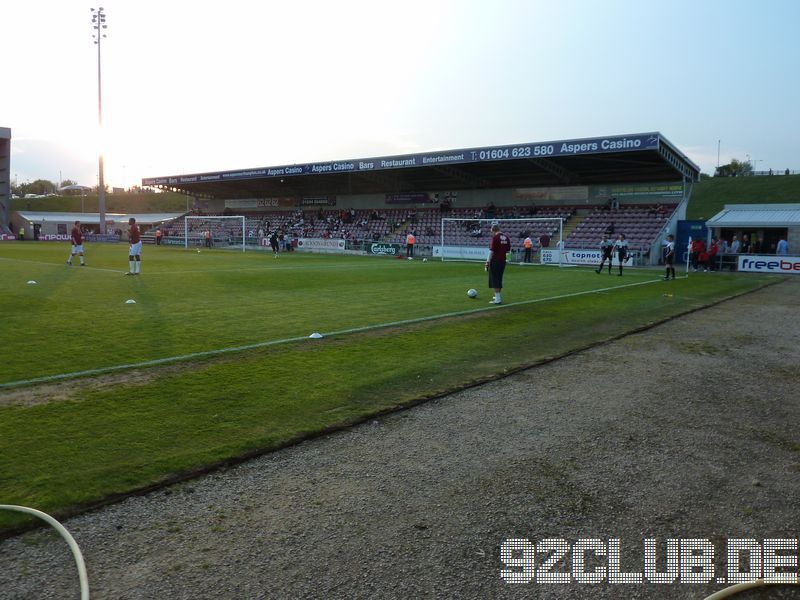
[0,243,770,527]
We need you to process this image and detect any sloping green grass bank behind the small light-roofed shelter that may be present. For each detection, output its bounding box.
[686,175,800,219]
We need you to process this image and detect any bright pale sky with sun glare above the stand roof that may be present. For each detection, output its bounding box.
[6,0,800,187]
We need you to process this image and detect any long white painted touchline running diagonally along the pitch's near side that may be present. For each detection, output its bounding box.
[0,276,686,390]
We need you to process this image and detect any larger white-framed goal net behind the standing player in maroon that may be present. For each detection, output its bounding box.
[434,217,564,264]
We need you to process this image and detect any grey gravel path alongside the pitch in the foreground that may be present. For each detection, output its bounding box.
[0,278,800,599]
